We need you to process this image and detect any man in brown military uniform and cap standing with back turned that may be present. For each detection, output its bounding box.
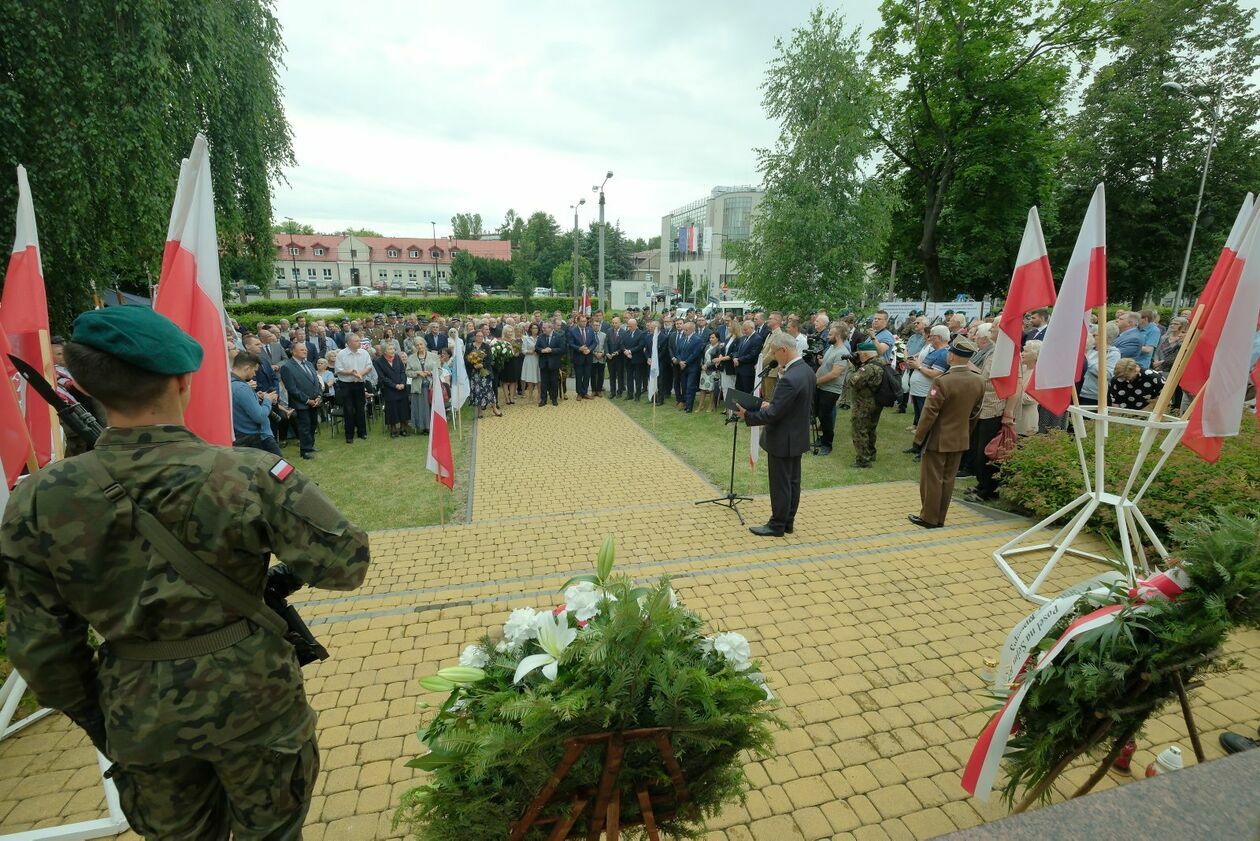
[910,337,984,528]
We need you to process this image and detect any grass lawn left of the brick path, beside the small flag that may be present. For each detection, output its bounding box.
[292,406,474,532]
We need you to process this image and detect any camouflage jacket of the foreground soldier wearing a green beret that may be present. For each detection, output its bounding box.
[0,426,369,763]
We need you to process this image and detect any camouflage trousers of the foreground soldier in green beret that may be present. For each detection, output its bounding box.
[110,733,319,841]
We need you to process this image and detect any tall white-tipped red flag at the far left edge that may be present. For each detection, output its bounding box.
[0,166,60,472]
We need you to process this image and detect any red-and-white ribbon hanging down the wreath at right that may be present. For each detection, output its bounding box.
[963,566,1189,801]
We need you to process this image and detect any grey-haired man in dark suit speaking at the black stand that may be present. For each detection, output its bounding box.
[736,333,814,537]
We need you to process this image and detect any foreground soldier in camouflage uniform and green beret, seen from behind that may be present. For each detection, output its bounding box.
[0,306,369,840]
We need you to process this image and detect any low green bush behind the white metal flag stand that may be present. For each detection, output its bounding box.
[1002,416,1260,535]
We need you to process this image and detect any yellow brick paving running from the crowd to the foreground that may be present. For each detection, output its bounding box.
[0,401,1260,841]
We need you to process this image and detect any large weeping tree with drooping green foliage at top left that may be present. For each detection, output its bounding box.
[0,0,294,325]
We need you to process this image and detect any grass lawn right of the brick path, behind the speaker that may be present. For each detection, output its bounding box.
[612,397,919,494]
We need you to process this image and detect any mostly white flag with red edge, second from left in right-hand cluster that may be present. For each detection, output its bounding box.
[1028,184,1106,415]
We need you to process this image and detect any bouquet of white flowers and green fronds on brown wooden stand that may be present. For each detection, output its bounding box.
[394,536,781,841]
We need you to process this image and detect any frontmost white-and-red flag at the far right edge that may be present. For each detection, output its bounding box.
[1182,206,1260,463]
